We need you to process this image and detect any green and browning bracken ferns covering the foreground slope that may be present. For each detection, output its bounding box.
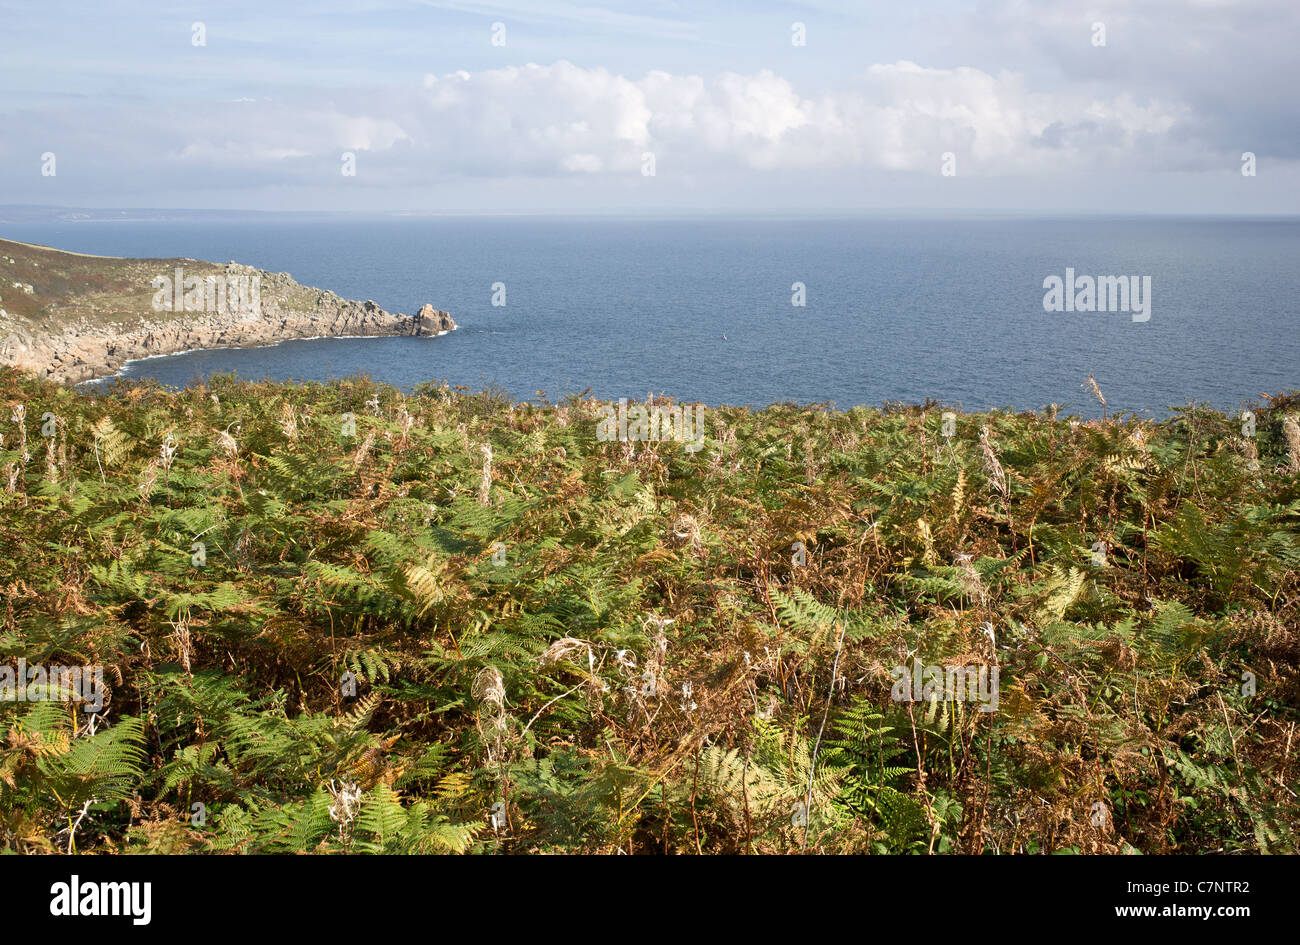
[0,372,1300,853]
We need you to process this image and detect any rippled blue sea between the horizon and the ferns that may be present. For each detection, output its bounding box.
[0,216,1300,416]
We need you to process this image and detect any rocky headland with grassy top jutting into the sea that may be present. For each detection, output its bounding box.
[0,240,456,382]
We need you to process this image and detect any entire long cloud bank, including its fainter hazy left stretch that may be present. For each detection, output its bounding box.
[0,53,1240,205]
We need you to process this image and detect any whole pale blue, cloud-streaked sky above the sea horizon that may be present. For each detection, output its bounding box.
[0,0,1300,214]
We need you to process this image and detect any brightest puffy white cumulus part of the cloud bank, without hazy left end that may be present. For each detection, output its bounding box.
[412,61,1183,174]
